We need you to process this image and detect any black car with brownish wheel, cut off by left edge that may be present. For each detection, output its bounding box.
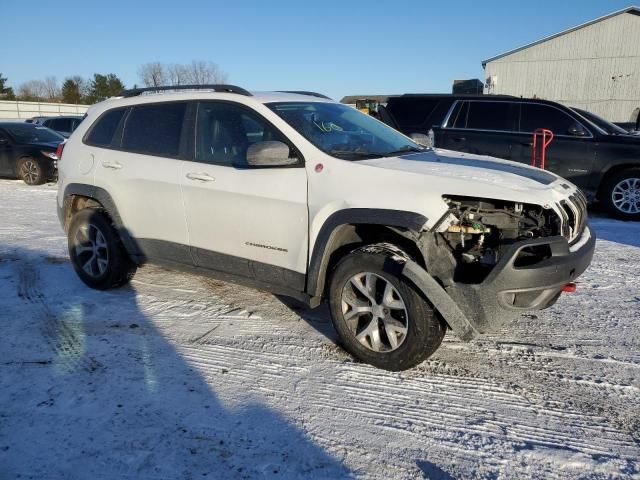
[0,122,64,185]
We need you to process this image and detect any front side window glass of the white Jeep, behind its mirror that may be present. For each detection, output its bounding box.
[196,102,287,167]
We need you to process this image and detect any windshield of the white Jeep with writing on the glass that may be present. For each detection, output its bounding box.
[267,102,424,160]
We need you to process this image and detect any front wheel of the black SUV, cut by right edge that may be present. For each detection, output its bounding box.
[602,168,640,220]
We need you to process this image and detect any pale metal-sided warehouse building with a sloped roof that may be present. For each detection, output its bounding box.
[482,7,640,122]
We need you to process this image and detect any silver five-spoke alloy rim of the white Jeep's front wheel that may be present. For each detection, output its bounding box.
[341,272,409,353]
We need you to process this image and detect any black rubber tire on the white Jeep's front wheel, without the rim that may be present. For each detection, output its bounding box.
[329,247,446,371]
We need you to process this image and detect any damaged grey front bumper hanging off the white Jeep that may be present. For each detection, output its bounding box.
[446,224,596,333]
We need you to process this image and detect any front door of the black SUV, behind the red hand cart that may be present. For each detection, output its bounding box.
[514,103,595,188]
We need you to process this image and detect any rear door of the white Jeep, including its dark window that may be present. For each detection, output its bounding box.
[88,102,192,264]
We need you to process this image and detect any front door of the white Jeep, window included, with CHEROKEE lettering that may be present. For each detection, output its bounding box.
[181,101,308,291]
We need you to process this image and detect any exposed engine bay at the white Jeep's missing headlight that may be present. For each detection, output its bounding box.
[423,196,561,285]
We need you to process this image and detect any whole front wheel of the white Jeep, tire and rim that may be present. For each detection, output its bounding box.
[329,249,446,371]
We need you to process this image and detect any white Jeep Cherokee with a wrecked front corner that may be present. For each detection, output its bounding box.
[57,85,595,370]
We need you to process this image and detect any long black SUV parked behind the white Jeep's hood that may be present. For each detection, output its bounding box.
[378,94,640,220]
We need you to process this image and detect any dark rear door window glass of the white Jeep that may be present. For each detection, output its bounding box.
[122,102,187,157]
